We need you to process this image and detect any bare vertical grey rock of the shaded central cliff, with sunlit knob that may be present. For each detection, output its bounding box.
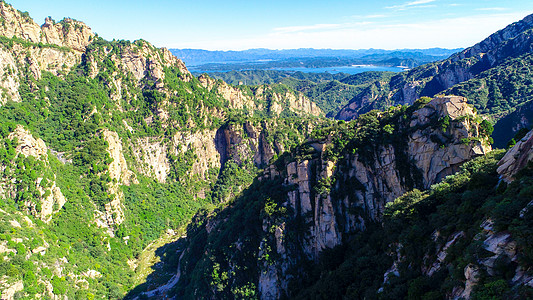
[175,97,491,299]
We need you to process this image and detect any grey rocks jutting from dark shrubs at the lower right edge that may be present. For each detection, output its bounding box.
[416,132,533,299]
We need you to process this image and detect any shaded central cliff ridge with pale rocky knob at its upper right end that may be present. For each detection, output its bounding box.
[170,97,490,299]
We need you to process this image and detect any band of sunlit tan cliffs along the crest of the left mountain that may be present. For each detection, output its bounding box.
[0,2,322,121]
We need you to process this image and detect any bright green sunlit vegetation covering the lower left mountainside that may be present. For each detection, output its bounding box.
[0,61,215,299]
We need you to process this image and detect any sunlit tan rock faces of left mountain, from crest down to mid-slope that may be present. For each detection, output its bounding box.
[0,2,321,220]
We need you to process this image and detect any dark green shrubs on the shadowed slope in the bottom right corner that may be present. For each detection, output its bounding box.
[292,151,533,299]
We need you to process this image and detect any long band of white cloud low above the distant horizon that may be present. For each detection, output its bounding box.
[168,12,531,50]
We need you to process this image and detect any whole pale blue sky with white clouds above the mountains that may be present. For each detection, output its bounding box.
[7,0,533,50]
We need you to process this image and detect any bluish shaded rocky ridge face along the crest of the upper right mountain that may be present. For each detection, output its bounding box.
[337,15,533,120]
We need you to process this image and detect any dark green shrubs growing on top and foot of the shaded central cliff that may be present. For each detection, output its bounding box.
[154,98,496,299]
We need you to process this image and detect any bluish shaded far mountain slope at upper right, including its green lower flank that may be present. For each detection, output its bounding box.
[337,15,533,146]
